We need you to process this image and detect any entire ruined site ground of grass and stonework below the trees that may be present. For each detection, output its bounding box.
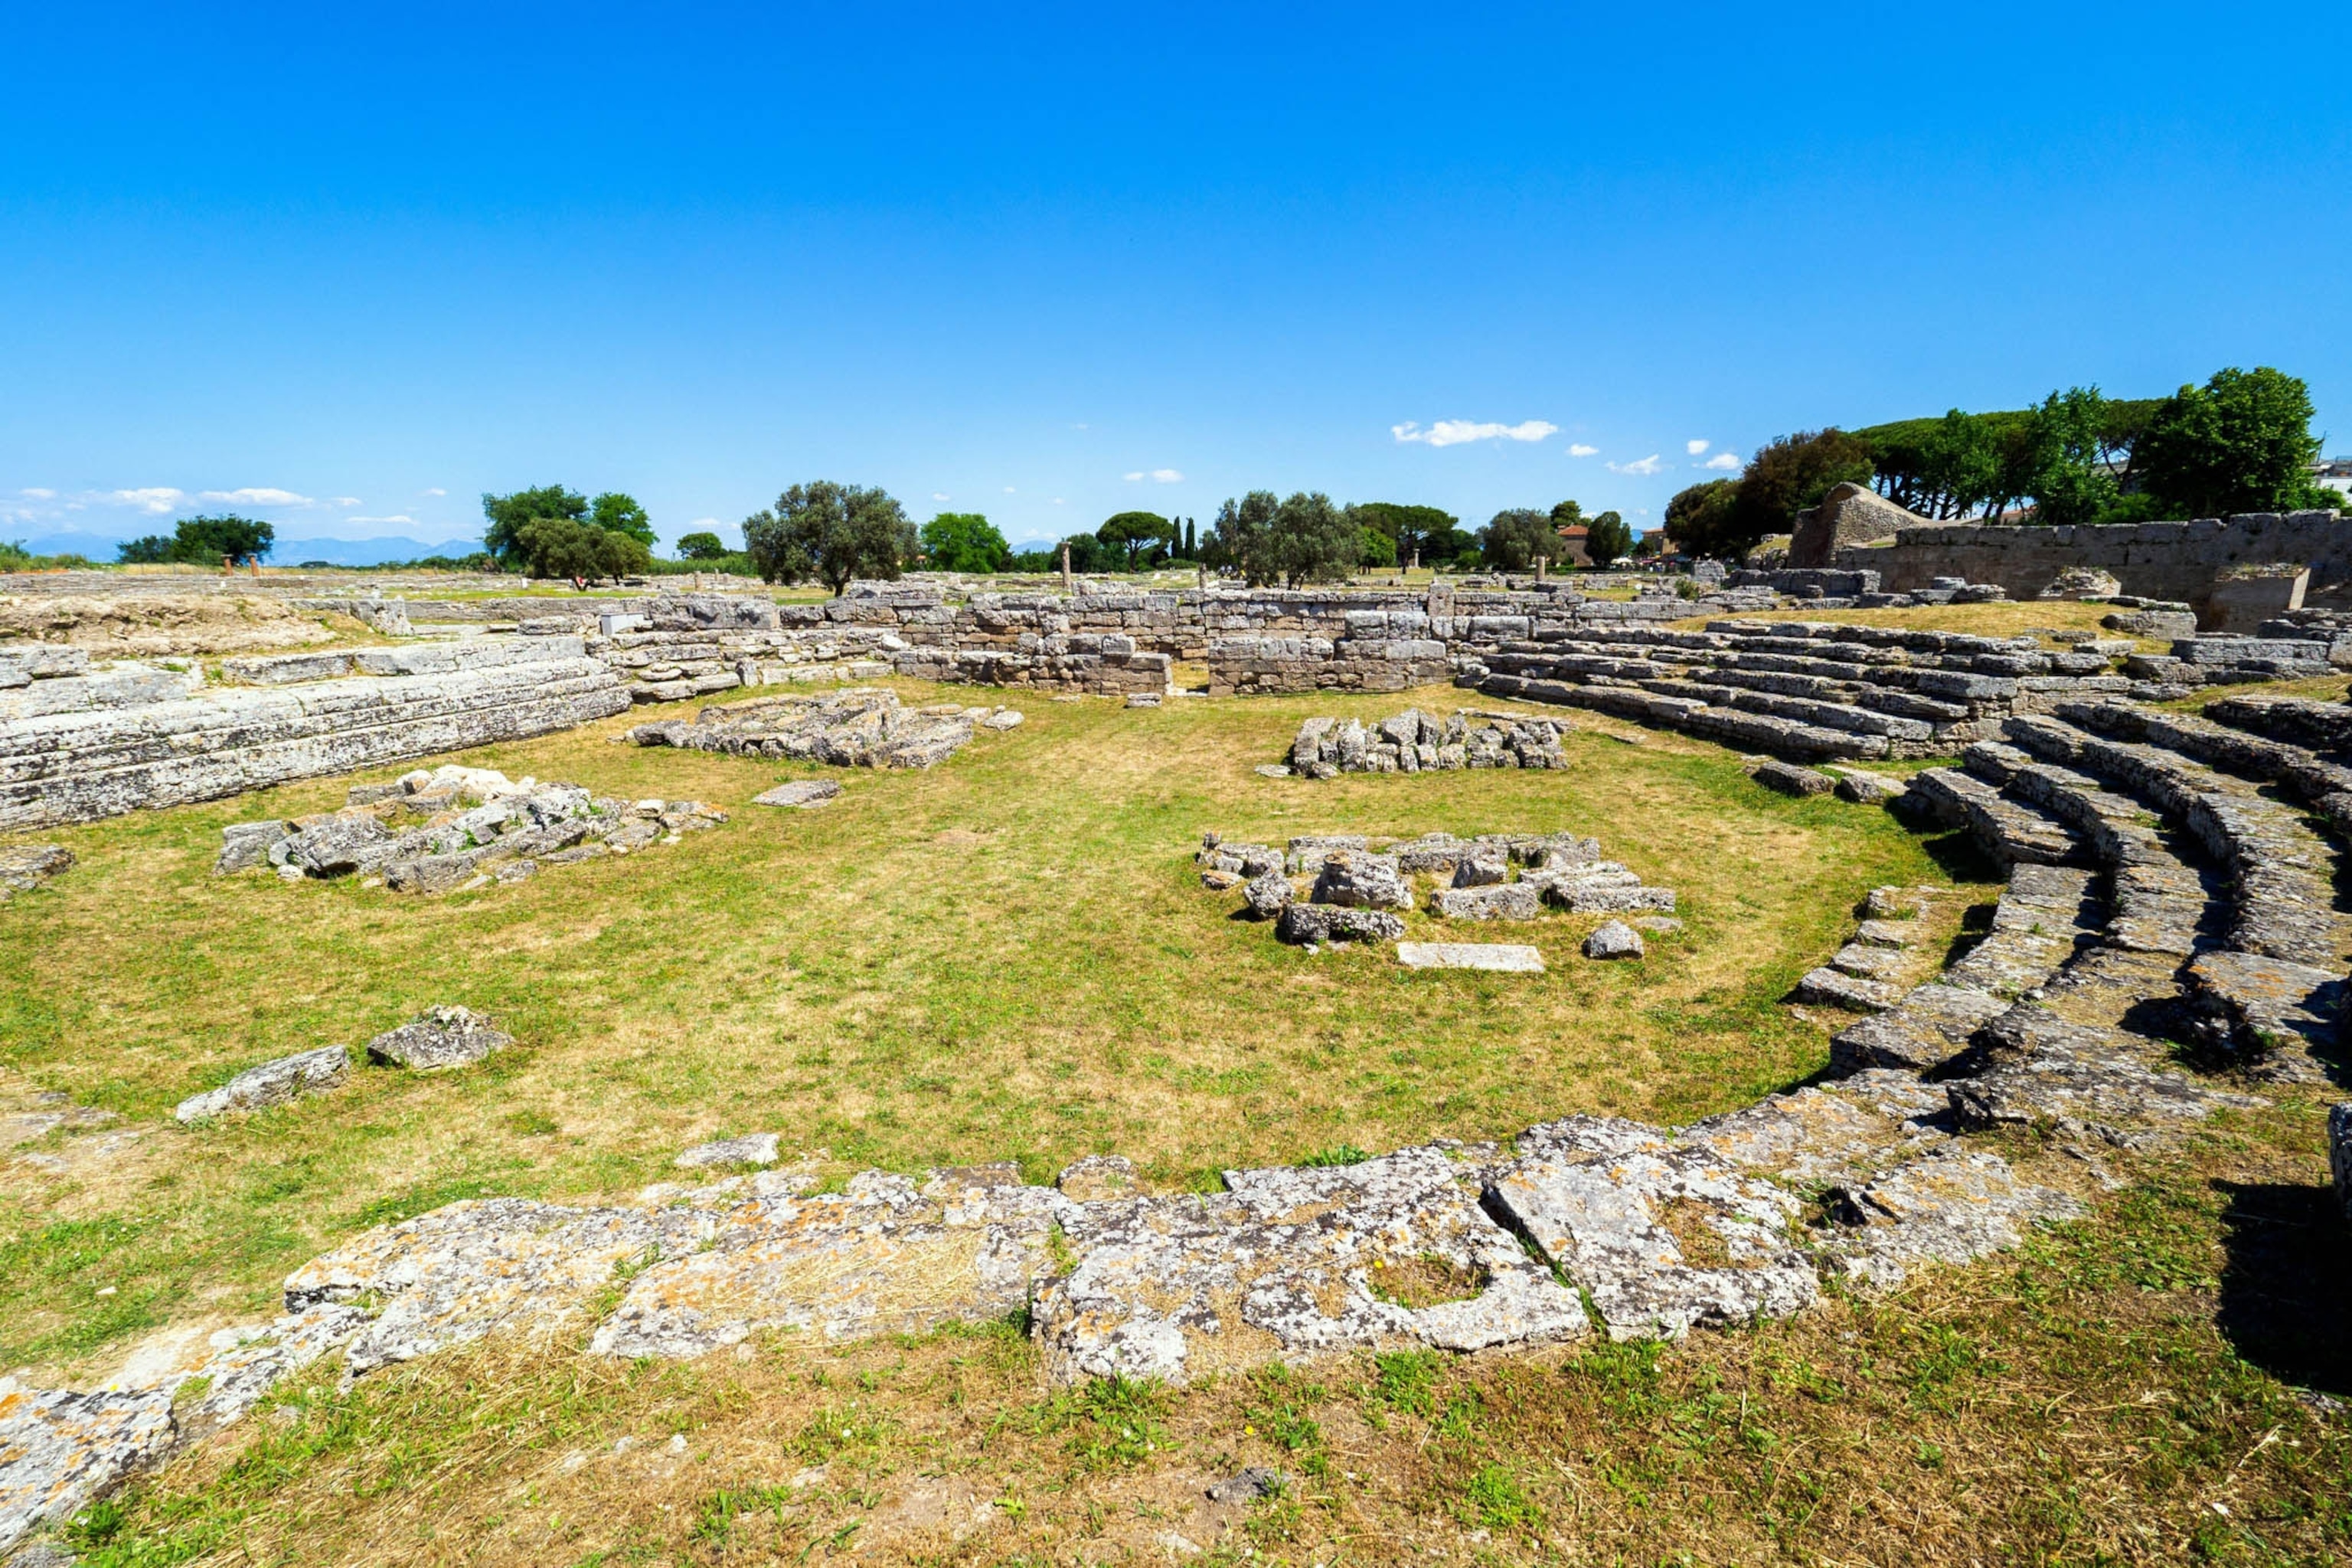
[0,557,2352,1566]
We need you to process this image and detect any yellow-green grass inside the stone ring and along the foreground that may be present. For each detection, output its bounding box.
[0,668,2352,1566]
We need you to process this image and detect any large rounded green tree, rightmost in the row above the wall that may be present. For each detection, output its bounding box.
[2133,364,2343,518]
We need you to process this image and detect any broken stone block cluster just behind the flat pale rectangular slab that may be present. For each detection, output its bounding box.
[1193,832,1674,945]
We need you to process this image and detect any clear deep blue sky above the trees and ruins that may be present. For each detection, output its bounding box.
[0,0,2352,557]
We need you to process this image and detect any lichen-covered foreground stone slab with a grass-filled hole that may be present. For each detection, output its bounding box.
[1033,1147,1590,1382]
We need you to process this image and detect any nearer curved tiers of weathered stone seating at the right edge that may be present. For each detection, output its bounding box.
[1832,701,2352,1099]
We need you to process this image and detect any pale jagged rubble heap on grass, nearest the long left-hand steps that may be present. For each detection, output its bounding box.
[214,766,727,893]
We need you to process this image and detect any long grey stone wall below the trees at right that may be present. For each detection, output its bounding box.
[1837,512,2352,604]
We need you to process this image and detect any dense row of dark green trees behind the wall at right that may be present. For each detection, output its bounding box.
[1665,364,2343,557]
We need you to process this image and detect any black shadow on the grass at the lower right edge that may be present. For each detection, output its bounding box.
[2213,1180,2352,1396]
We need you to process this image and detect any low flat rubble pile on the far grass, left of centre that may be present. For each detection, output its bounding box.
[628,687,1011,769]
